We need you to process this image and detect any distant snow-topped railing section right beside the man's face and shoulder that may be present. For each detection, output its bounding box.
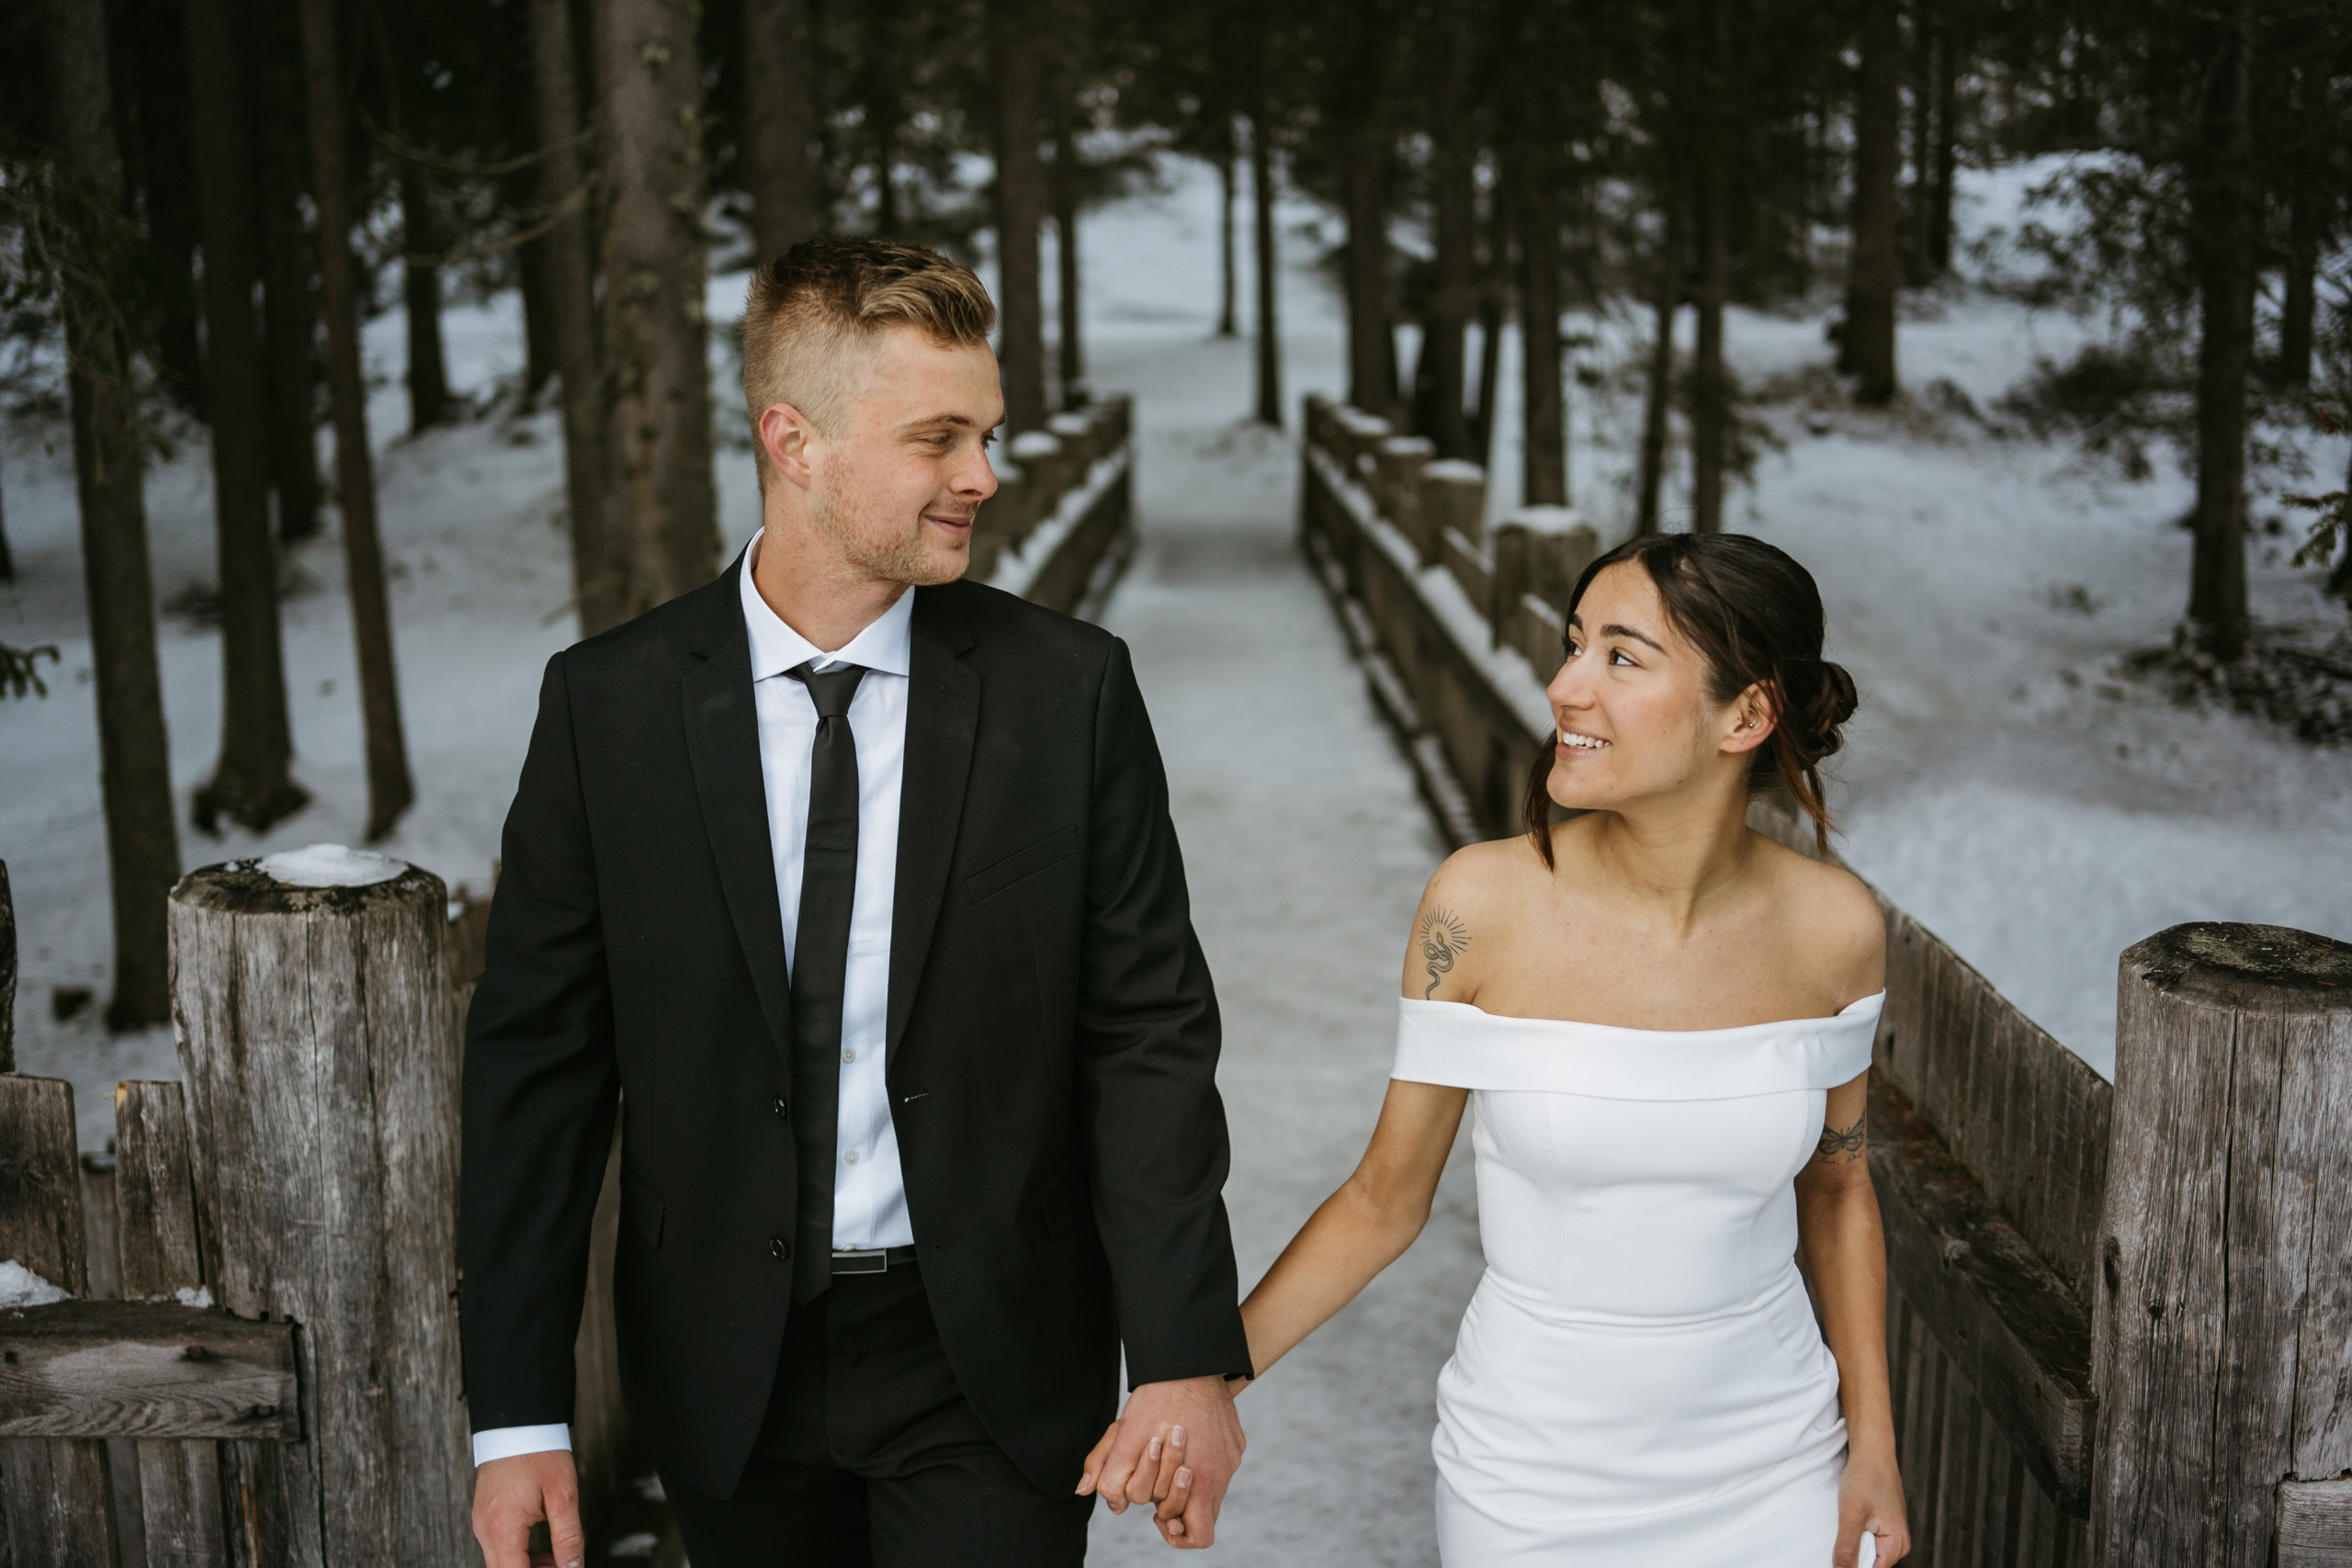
[971,398,1134,614]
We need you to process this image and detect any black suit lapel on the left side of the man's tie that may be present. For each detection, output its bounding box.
[680,570,793,1065]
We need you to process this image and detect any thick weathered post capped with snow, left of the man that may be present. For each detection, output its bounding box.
[172,846,475,1568]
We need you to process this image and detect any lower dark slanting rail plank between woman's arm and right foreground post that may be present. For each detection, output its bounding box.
[1870,1084,2096,1506]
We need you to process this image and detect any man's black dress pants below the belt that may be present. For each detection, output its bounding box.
[661,1265,1093,1568]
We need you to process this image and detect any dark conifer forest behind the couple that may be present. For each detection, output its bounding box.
[0,0,2352,1128]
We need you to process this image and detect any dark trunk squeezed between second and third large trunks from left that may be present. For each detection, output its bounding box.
[261,26,320,543]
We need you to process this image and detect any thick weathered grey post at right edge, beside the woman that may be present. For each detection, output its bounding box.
[2091,924,2352,1568]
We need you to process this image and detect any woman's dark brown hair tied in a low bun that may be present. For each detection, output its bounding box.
[1526,534,1853,865]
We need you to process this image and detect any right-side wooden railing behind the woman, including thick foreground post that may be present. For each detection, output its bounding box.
[1301,400,2352,1568]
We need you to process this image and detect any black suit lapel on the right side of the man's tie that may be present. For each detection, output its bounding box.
[885,588,981,1065]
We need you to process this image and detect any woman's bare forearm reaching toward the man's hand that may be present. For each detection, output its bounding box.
[1242,1079,1470,1378]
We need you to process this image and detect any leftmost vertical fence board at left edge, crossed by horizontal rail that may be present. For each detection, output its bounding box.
[0,1072,120,1568]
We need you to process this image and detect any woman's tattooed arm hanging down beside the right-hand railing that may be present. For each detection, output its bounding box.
[1797,1072,1910,1568]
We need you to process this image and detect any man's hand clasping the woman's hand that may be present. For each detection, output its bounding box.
[1077,1378,1249,1568]
